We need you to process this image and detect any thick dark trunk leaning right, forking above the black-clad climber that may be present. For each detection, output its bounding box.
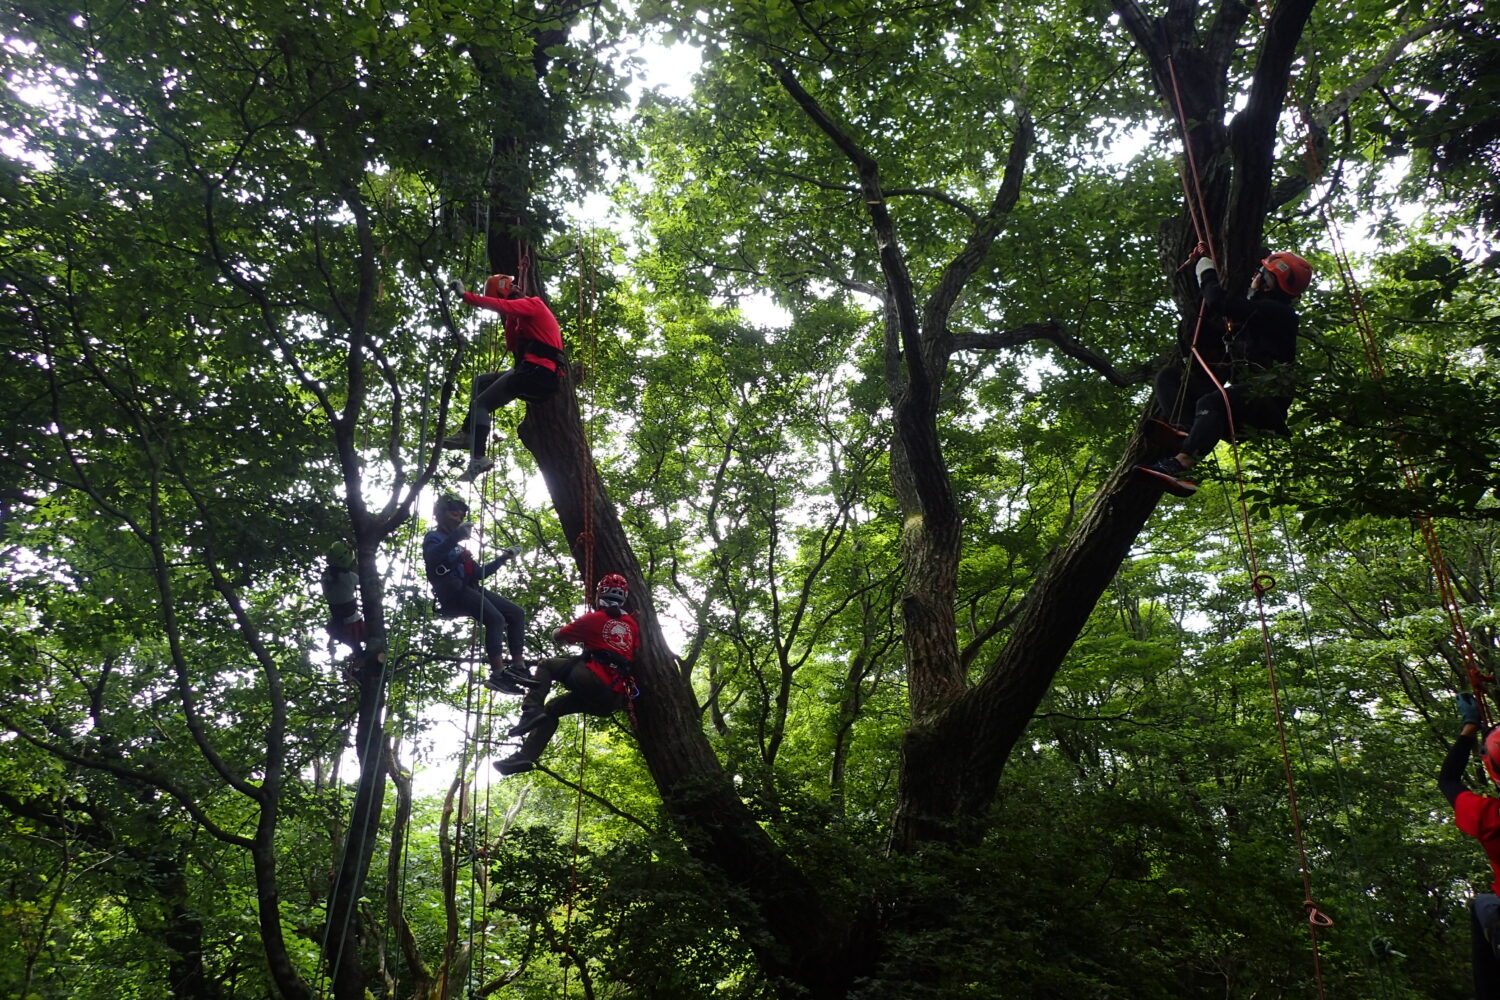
[893,0,1316,850]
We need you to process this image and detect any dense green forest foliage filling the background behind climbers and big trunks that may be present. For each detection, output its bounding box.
[0,0,1500,1000]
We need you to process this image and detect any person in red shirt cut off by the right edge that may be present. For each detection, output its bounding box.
[1437,694,1500,1000]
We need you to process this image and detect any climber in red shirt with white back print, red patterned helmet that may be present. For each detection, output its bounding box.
[495,573,641,774]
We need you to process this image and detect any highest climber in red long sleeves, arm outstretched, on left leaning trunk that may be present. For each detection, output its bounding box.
[443,274,564,483]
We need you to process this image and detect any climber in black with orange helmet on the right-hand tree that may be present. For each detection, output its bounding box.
[1136,247,1313,496]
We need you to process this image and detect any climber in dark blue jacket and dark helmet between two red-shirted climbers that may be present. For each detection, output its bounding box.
[422,493,536,694]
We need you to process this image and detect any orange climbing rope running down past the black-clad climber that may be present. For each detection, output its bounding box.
[1167,55,1334,999]
